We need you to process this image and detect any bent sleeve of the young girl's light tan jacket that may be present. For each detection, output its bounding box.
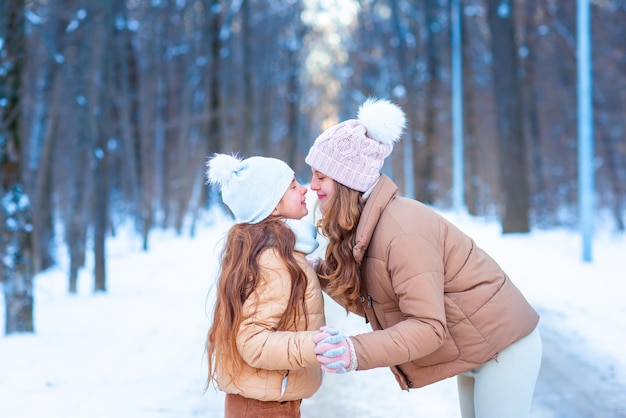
[237,251,319,370]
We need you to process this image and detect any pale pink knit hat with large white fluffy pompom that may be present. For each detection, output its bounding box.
[304,99,406,192]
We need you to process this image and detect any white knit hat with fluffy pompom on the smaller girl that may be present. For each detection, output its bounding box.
[206,154,294,224]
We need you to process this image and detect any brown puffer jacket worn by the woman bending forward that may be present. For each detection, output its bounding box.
[352,175,539,389]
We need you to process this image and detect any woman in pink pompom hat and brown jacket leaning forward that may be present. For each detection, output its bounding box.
[305,99,541,418]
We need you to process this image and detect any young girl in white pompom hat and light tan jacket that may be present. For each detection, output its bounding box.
[206,154,324,418]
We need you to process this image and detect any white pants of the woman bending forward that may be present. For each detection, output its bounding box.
[457,328,542,418]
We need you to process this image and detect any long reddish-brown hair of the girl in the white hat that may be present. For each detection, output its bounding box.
[206,217,308,386]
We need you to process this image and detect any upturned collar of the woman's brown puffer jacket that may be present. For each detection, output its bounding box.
[352,174,398,263]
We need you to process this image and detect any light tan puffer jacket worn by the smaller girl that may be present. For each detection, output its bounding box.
[218,249,325,402]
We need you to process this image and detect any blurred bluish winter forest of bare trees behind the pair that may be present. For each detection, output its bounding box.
[0,0,626,334]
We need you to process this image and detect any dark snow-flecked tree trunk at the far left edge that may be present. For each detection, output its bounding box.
[0,0,34,334]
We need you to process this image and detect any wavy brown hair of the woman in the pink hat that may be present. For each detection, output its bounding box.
[318,182,365,310]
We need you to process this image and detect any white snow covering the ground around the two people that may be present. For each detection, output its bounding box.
[0,207,626,418]
